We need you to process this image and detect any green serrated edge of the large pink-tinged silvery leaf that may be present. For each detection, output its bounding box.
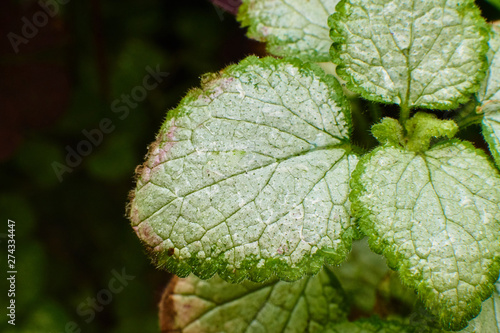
[127,56,360,283]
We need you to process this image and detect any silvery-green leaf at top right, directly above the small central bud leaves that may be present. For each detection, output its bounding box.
[329,0,487,109]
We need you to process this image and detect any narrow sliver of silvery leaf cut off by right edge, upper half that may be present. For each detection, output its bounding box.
[477,25,500,167]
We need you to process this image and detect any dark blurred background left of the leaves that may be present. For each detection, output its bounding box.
[0,0,496,333]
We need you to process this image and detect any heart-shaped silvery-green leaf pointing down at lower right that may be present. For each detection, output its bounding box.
[351,141,500,330]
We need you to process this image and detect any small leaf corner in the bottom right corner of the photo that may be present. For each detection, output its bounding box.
[460,281,500,333]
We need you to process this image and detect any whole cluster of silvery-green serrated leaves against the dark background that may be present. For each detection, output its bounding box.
[129,0,500,333]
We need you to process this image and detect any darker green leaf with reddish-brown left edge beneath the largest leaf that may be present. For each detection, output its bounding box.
[160,269,347,333]
